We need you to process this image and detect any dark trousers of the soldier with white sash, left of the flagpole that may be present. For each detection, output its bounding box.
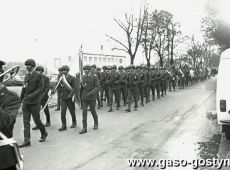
[61,98,77,126]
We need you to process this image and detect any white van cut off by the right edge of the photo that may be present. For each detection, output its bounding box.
[216,48,230,139]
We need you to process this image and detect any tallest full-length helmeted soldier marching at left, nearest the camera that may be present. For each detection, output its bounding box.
[19,59,48,147]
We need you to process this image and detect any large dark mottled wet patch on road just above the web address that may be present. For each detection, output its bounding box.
[196,134,221,159]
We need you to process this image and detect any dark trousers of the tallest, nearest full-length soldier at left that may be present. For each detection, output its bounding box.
[22,103,46,141]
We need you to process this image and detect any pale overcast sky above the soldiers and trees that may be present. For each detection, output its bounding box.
[0,0,205,64]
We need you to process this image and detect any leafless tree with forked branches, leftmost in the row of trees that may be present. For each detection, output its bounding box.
[106,6,147,64]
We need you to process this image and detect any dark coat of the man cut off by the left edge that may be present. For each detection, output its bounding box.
[0,82,21,170]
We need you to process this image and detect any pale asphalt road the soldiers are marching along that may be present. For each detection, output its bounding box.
[14,78,226,170]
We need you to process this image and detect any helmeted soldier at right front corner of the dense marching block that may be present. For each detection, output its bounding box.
[125,65,139,112]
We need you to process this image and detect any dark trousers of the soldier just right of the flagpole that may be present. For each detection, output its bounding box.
[82,100,98,129]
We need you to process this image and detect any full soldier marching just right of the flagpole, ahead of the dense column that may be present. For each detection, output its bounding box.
[79,65,100,134]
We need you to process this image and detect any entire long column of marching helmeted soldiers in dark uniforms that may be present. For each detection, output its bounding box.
[0,59,214,168]
